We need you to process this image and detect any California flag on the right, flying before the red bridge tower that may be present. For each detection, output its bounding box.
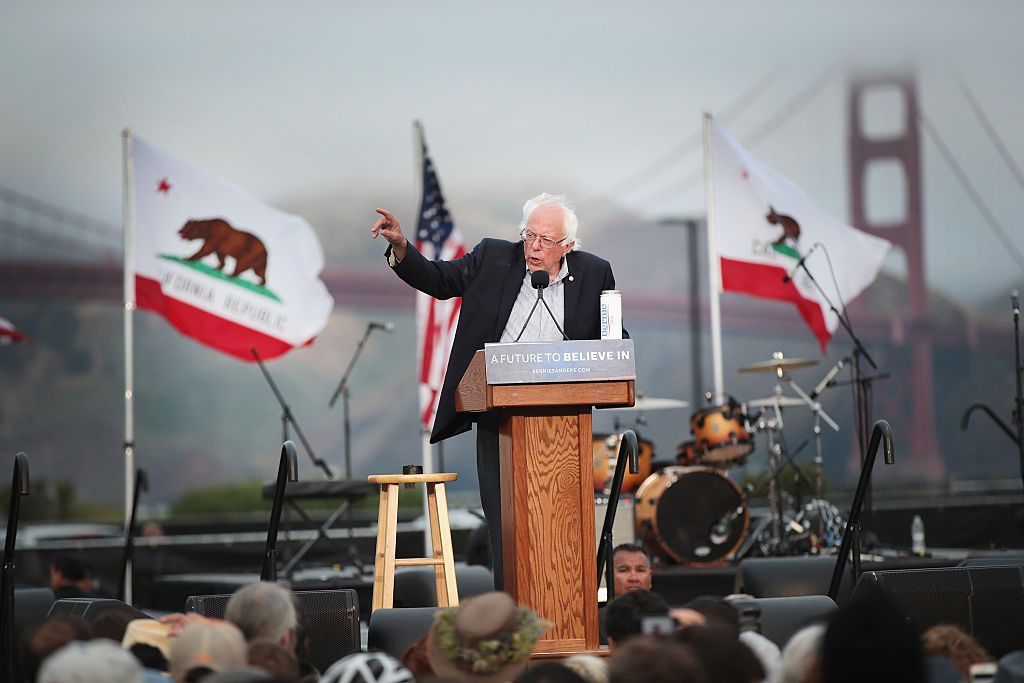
[711,121,892,351]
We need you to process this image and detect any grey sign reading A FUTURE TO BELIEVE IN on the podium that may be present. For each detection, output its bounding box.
[483,339,637,384]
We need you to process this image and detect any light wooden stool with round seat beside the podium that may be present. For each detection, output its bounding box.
[367,473,459,611]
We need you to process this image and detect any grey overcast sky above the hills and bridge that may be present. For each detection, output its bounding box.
[0,0,1024,302]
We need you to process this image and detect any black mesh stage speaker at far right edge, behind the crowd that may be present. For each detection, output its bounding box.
[858,565,1024,657]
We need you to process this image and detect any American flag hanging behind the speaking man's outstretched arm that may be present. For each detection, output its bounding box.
[416,134,466,431]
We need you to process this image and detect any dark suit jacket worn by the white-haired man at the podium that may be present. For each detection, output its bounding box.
[386,239,626,443]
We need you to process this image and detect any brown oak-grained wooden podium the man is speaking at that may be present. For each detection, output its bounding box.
[456,351,635,654]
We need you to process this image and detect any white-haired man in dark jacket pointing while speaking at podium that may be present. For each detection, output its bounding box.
[373,193,628,590]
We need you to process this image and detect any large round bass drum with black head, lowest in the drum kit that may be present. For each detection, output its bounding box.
[635,467,751,566]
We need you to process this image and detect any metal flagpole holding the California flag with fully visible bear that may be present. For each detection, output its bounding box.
[121,128,135,604]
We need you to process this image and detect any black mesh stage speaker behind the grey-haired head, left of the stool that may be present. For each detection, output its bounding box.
[185,589,360,672]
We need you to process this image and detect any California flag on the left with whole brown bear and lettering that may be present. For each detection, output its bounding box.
[129,137,334,360]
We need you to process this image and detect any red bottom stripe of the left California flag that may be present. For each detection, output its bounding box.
[135,274,313,362]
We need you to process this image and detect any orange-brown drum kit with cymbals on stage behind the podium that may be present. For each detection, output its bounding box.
[593,352,846,566]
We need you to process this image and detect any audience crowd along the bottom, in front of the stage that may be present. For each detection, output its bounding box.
[18,547,1007,683]
